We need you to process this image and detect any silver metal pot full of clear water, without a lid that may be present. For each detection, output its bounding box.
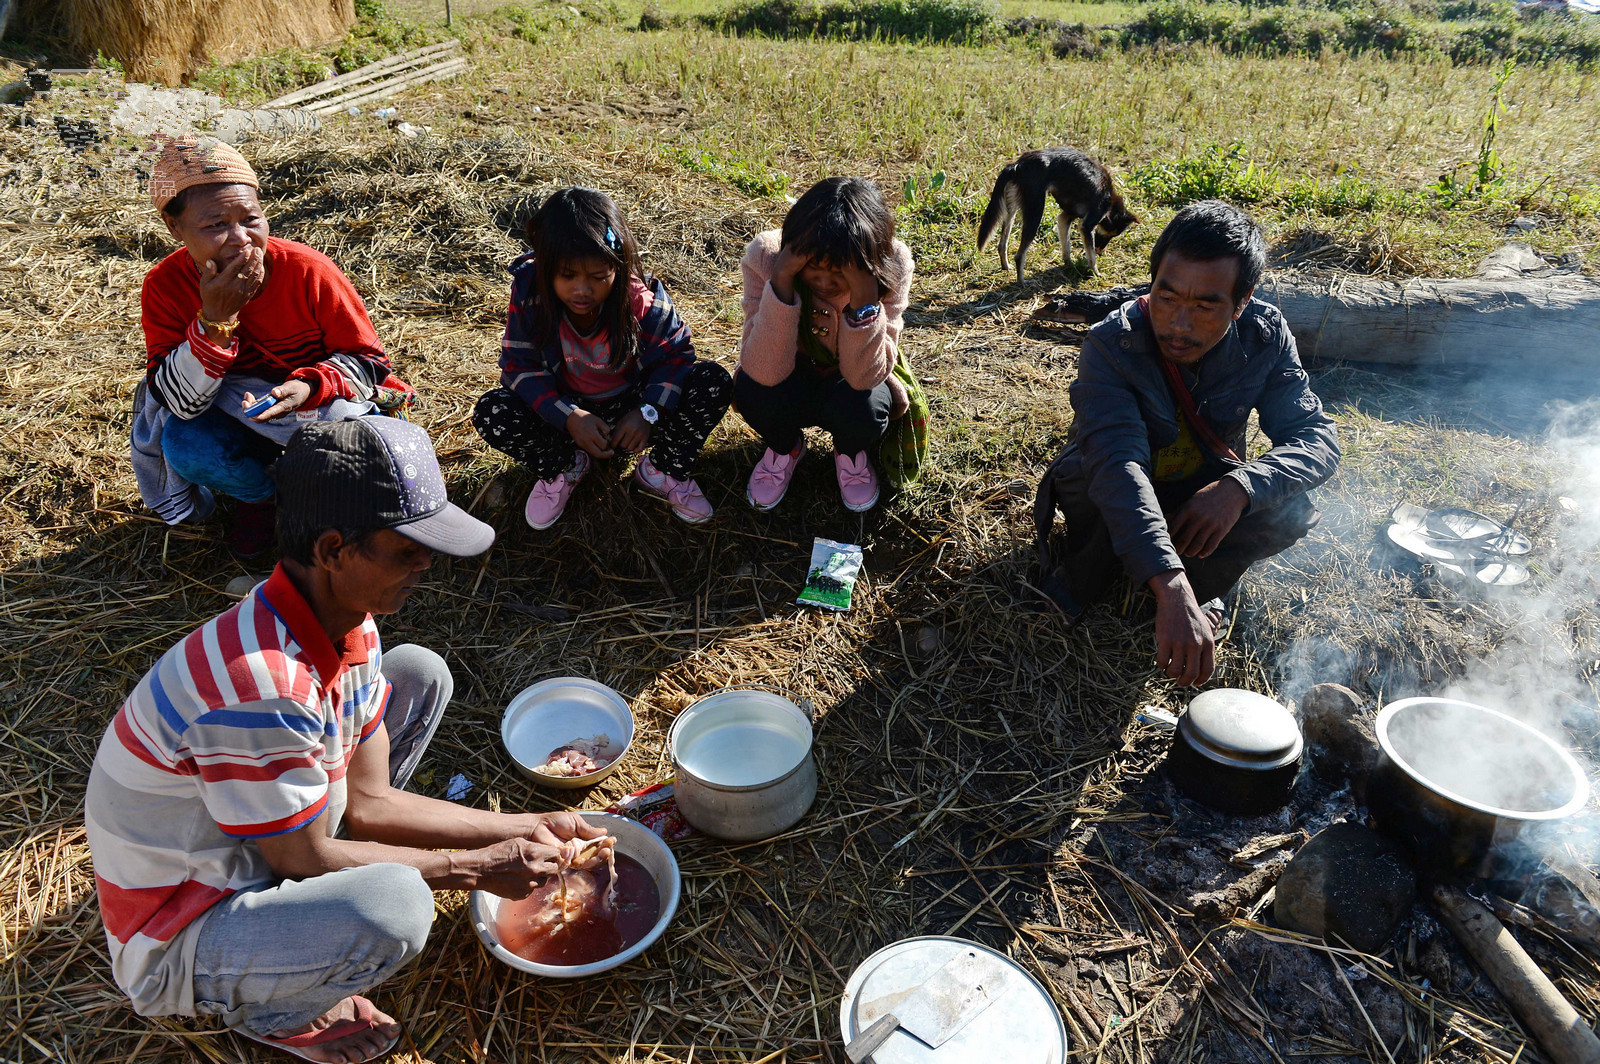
[667,686,816,842]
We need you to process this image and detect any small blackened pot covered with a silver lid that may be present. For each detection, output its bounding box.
[1166,688,1306,816]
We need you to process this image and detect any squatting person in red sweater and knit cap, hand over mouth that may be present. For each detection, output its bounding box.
[131,138,411,558]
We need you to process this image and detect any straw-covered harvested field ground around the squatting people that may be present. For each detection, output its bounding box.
[0,0,1600,1064]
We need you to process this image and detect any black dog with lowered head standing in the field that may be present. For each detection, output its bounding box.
[978,147,1139,282]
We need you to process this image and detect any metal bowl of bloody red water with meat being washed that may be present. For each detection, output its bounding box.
[470,813,682,979]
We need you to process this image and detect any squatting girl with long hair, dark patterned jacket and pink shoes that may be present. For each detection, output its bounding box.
[472,189,733,528]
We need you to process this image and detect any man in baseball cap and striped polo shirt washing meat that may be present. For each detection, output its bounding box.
[85,418,603,1061]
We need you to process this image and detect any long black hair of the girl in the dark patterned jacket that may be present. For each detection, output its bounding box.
[523,187,645,370]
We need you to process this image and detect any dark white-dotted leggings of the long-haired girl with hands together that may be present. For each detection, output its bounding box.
[472,360,733,480]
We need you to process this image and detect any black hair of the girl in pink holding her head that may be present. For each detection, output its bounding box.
[782,178,904,299]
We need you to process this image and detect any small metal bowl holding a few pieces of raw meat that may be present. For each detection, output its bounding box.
[501,677,634,790]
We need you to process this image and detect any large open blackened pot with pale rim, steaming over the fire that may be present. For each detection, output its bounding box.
[1366,698,1589,875]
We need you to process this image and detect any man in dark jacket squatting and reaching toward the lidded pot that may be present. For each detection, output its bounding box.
[1035,200,1339,683]
